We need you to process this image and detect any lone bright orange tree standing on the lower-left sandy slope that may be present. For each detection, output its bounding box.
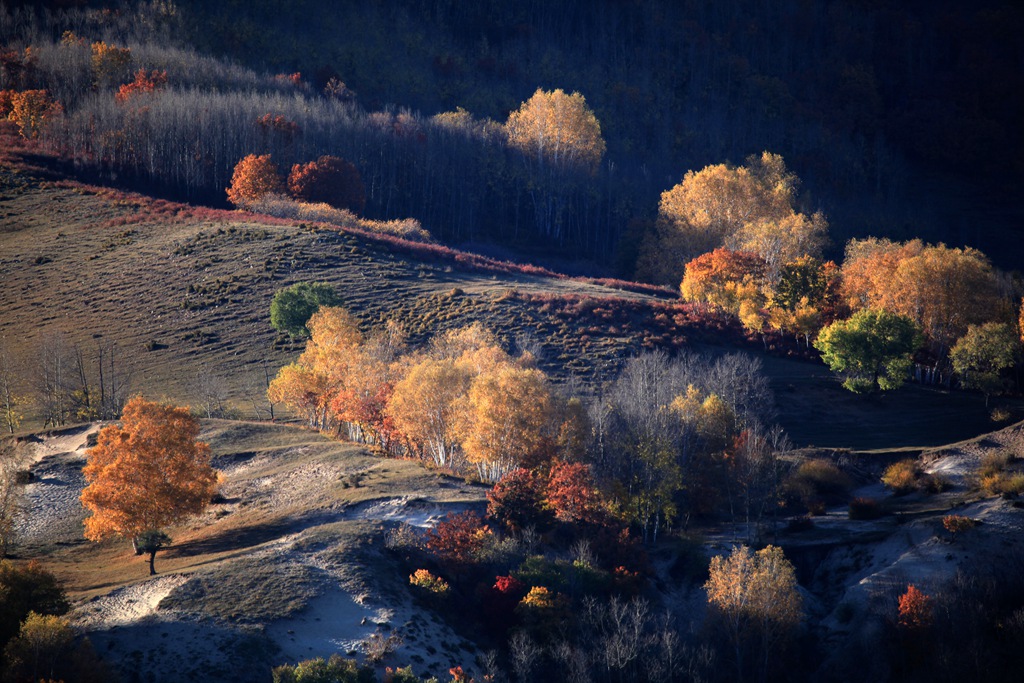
[82,396,217,574]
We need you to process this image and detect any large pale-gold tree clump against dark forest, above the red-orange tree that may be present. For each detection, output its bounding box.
[637,152,828,282]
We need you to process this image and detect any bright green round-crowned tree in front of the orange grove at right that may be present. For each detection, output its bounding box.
[814,308,923,393]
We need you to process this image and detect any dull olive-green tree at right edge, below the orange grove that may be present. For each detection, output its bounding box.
[949,323,1020,405]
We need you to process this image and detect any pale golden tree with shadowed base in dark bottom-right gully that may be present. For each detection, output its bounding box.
[705,546,802,680]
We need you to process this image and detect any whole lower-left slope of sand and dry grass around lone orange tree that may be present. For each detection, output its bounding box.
[18,421,484,682]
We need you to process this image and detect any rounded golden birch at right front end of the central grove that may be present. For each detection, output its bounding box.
[458,365,552,481]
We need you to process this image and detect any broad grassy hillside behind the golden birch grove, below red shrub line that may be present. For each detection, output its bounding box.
[0,148,1017,450]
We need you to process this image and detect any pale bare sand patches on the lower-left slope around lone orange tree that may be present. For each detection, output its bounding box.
[17,426,474,683]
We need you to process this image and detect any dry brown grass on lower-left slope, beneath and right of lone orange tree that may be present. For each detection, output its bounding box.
[25,420,485,610]
